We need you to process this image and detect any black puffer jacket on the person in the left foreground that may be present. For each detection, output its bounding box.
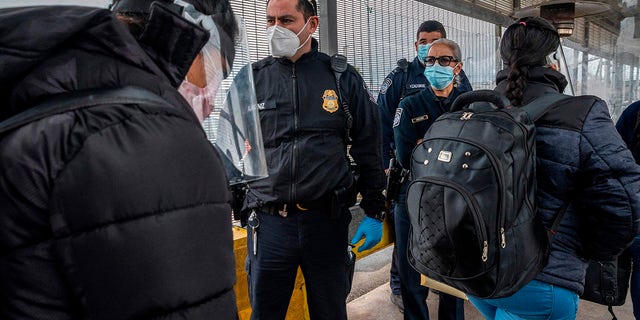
[0,7,236,320]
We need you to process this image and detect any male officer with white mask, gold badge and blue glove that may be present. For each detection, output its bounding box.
[244,0,384,320]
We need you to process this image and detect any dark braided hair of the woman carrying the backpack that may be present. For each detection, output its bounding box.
[500,17,560,106]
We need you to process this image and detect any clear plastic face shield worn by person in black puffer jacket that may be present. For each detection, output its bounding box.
[174,0,267,185]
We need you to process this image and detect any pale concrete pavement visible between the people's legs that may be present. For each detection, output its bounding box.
[347,246,634,320]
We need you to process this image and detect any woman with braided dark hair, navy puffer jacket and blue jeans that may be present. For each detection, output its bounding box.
[469,17,640,320]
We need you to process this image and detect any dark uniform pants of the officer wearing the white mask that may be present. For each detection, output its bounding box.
[246,207,351,320]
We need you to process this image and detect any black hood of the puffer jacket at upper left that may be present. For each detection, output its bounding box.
[0,6,208,120]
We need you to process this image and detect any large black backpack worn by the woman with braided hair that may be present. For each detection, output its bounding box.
[407,90,569,298]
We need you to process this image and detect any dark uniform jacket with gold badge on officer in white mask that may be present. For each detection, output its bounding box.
[249,39,384,214]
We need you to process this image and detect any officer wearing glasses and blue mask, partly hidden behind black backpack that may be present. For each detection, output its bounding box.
[393,39,466,320]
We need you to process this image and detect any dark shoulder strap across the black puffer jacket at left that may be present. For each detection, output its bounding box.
[0,86,169,133]
